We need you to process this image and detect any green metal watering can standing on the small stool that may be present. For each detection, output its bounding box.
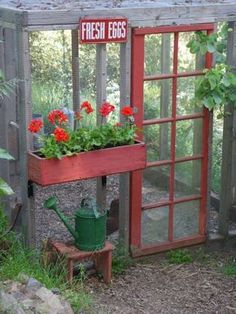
[44,197,107,251]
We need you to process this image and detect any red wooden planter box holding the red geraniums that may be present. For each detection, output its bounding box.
[28,142,146,186]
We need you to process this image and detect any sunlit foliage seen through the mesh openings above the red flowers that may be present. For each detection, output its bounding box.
[30,31,120,111]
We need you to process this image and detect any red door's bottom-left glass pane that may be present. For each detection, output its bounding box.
[142,207,169,245]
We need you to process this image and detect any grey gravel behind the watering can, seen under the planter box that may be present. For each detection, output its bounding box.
[35,176,119,247]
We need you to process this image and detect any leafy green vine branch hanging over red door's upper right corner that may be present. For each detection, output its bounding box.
[187,24,236,118]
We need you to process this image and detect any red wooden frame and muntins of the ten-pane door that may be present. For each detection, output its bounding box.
[130,24,214,256]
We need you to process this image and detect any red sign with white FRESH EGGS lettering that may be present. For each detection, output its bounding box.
[80,18,128,44]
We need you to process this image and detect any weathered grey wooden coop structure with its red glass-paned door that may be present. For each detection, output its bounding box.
[0,0,236,256]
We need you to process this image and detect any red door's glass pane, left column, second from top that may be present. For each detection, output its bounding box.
[144,79,172,120]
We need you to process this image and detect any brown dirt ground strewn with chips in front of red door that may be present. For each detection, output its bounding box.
[86,253,236,314]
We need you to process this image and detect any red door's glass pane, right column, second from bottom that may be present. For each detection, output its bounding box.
[175,160,201,198]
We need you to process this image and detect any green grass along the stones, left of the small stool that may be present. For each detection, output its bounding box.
[0,206,92,312]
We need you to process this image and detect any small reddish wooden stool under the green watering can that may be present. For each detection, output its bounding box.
[50,240,113,284]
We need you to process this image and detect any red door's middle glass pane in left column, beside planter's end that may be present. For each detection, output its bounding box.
[143,123,171,162]
